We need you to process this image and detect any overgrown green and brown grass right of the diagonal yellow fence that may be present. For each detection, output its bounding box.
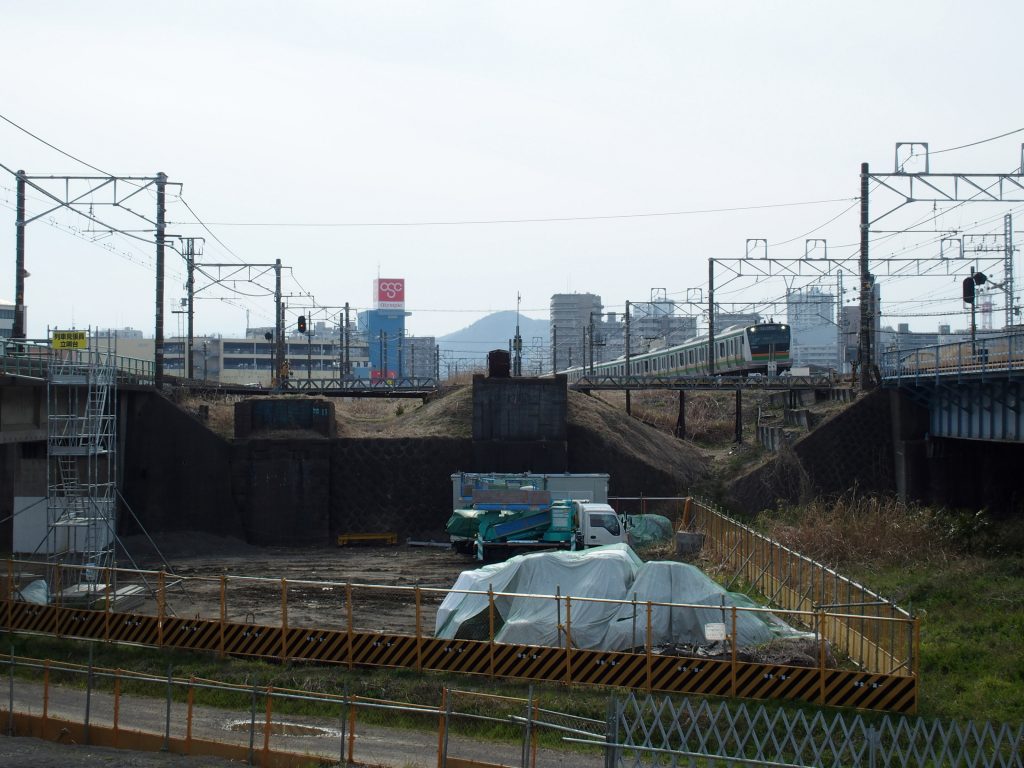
[758,495,1024,723]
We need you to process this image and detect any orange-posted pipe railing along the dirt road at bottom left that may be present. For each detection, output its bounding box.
[0,649,607,768]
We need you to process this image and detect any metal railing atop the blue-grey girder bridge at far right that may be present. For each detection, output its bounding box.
[882,333,1024,385]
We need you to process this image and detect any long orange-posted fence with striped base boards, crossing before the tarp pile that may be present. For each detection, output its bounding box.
[0,552,918,712]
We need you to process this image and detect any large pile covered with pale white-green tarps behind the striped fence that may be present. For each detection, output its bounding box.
[435,544,807,650]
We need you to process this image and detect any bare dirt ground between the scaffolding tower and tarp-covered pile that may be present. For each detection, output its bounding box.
[119,534,476,634]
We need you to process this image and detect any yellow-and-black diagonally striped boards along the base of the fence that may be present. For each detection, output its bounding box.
[0,599,918,713]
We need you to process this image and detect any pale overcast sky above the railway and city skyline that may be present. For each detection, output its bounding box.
[0,0,1024,338]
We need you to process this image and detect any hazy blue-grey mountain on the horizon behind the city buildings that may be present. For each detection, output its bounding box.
[437,309,550,376]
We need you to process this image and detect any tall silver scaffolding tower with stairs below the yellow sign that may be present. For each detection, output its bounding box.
[46,350,117,594]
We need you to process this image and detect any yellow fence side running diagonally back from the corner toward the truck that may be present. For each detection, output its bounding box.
[683,499,921,676]
